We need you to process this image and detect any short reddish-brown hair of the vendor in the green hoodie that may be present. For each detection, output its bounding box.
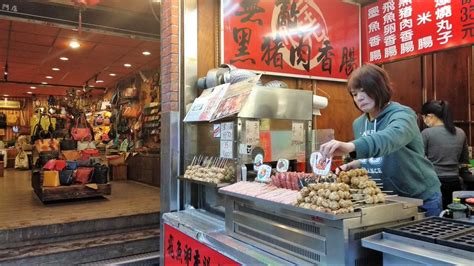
[347,64,393,110]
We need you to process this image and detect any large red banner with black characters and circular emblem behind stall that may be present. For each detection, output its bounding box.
[222,0,360,80]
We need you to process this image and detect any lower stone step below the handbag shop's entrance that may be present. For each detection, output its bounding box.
[0,228,160,266]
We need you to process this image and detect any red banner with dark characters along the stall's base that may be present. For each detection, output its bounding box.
[164,224,240,265]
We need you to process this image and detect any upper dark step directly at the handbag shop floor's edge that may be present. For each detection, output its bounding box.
[0,212,160,249]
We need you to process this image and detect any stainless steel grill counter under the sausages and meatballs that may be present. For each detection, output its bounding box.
[220,190,422,265]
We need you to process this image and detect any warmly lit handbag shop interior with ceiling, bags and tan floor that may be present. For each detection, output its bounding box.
[0,1,161,262]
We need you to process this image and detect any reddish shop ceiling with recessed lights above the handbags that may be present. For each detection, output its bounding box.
[0,0,160,97]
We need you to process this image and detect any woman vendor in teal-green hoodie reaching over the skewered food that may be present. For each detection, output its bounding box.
[320,64,442,216]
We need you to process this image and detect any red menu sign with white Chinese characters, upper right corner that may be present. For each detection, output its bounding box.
[362,0,474,63]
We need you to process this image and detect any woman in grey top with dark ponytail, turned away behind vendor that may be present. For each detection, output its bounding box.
[421,101,469,208]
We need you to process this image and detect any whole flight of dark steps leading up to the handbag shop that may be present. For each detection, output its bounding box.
[0,212,160,265]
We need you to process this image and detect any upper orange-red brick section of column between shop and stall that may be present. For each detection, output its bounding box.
[160,0,180,112]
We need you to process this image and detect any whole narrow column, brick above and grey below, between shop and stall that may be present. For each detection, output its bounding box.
[160,0,182,214]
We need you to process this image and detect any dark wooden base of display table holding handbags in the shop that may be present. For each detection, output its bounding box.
[31,170,112,202]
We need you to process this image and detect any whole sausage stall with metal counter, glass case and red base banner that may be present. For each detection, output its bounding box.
[162,76,422,265]
